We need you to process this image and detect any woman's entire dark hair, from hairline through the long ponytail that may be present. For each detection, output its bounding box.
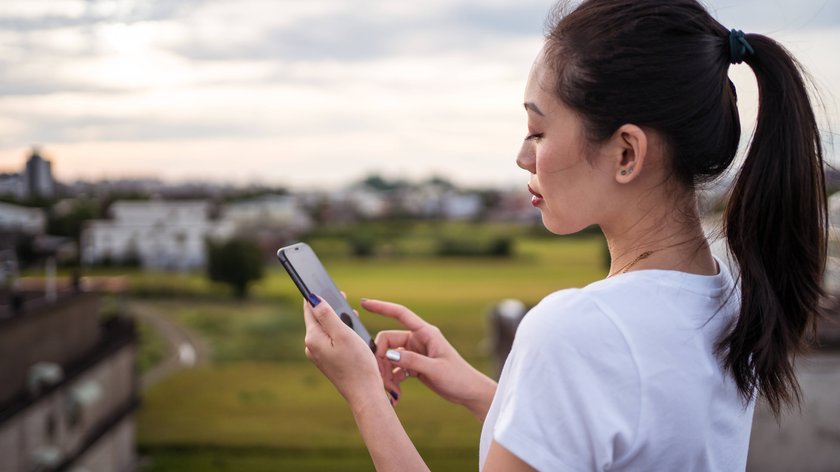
[545,0,828,415]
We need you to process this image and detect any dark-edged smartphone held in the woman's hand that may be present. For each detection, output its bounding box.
[277,243,376,352]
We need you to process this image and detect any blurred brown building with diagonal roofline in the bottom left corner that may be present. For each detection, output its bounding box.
[0,291,138,472]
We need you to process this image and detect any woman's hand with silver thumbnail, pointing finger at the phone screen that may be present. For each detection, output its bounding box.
[362,300,496,421]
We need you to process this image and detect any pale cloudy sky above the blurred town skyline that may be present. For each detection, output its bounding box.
[0,0,840,189]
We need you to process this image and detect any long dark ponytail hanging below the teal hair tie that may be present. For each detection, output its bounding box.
[719,34,828,416]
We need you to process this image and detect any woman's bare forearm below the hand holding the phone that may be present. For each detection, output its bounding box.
[350,395,429,472]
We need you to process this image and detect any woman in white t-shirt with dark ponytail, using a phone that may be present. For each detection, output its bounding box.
[304,0,827,471]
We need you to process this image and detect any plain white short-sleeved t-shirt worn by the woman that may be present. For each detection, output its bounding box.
[479,262,755,471]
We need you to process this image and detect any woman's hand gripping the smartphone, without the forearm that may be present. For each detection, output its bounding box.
[303,298,383,407]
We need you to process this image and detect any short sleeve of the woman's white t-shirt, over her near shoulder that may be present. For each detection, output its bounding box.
[493,290,641,471]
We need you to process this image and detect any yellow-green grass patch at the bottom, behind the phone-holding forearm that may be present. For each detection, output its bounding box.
[136,363,481,470]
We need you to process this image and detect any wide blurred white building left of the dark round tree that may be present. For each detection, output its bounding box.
[82,201,234,270]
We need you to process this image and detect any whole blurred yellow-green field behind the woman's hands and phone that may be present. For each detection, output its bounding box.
[132,238,604,471]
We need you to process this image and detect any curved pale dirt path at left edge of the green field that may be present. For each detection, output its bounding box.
[126,300,209,389]
